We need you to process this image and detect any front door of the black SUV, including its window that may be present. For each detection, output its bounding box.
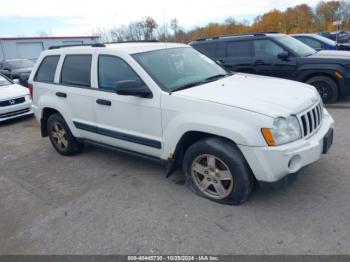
[253,39,297,78]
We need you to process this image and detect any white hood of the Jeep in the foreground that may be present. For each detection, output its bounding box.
[173,73,320,117]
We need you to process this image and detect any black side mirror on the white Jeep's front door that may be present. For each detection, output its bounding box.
[116,80,152,98]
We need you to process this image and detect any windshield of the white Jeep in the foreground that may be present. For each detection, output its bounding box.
[133,47,228,92]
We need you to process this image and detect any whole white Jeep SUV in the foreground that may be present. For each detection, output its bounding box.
[29,43,334,204]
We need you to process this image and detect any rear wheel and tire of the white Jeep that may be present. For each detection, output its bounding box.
[47,113,83,156]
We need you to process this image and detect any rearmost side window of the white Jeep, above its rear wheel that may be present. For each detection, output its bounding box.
[34,55,60,83]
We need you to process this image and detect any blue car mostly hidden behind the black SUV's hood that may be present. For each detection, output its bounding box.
[291,34,350,51]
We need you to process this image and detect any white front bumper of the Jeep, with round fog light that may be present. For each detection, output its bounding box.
[239,110,334,183]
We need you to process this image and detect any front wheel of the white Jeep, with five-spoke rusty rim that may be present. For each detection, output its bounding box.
[183,137,254,205]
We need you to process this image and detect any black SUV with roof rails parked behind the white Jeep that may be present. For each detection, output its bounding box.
[190,33,350,103]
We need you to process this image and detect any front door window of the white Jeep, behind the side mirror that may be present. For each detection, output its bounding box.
[98,55,142,91]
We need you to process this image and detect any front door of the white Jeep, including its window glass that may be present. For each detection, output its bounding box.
[94,54,162,157]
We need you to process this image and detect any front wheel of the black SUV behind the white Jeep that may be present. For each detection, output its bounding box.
[306,76,339,104]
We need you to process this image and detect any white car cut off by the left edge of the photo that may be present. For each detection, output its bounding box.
[0,74,33,122]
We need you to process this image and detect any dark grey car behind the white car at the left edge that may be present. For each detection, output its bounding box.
[0,59,34,86]
